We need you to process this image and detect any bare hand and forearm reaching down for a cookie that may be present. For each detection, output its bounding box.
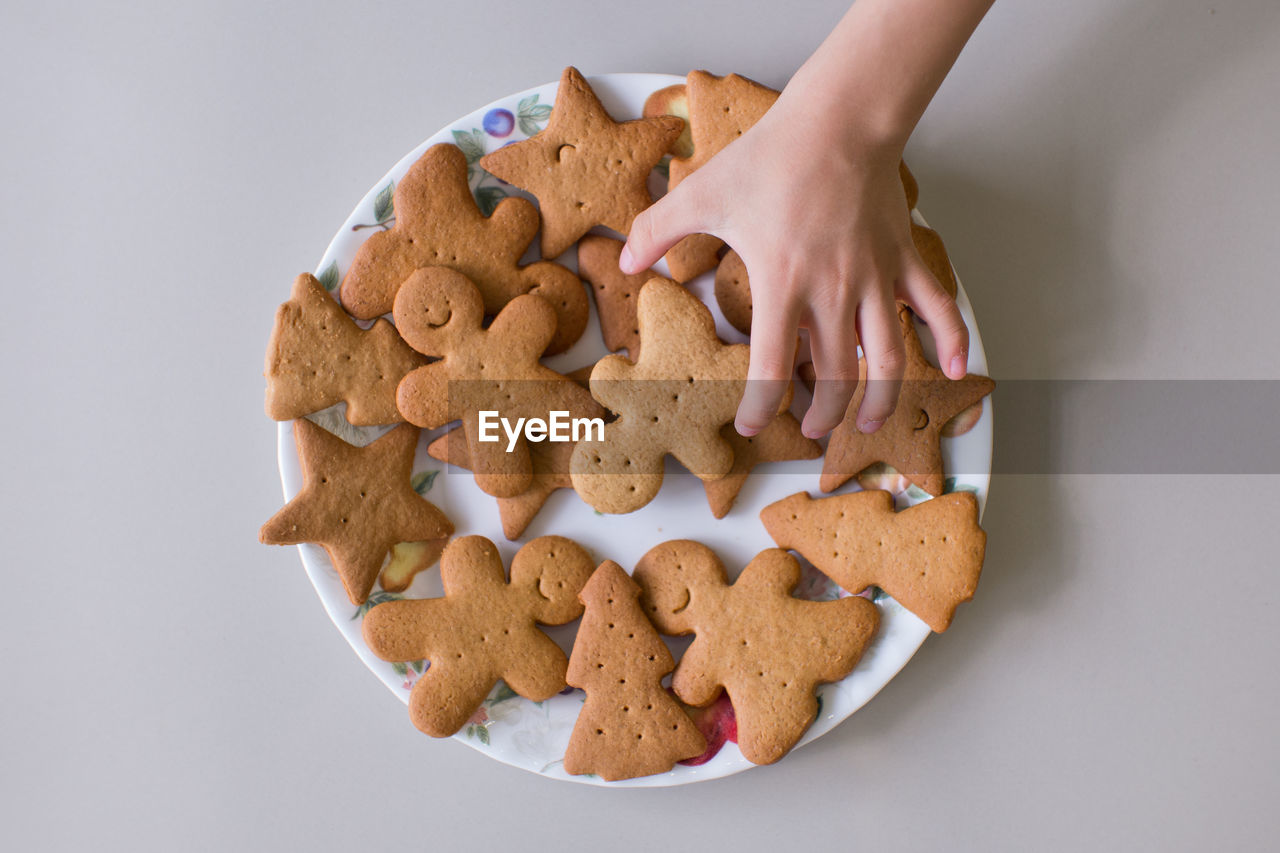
[620,0,992,438]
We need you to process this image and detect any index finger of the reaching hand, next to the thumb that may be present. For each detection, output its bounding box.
[735,282,800,437]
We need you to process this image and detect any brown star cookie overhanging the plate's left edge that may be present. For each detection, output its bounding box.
[259,419,453,605]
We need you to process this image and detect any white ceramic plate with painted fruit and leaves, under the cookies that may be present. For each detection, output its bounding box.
[270,74,992,786]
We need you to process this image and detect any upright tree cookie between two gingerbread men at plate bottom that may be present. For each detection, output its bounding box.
[564,560,707,781]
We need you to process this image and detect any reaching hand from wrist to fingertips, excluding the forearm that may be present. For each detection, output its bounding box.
[620,93,969,438]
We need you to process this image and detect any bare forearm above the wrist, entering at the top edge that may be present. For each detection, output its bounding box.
[781,0,993,152]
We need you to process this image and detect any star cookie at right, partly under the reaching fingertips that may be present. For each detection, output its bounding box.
[819,306,996,494]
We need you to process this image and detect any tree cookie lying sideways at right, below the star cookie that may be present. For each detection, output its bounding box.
[760,491,987,633]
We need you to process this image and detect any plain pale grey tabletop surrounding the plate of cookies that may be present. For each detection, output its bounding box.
[0,0,1280,850]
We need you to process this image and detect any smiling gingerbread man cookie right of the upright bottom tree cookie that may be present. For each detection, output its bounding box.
[635,539,879,765]
